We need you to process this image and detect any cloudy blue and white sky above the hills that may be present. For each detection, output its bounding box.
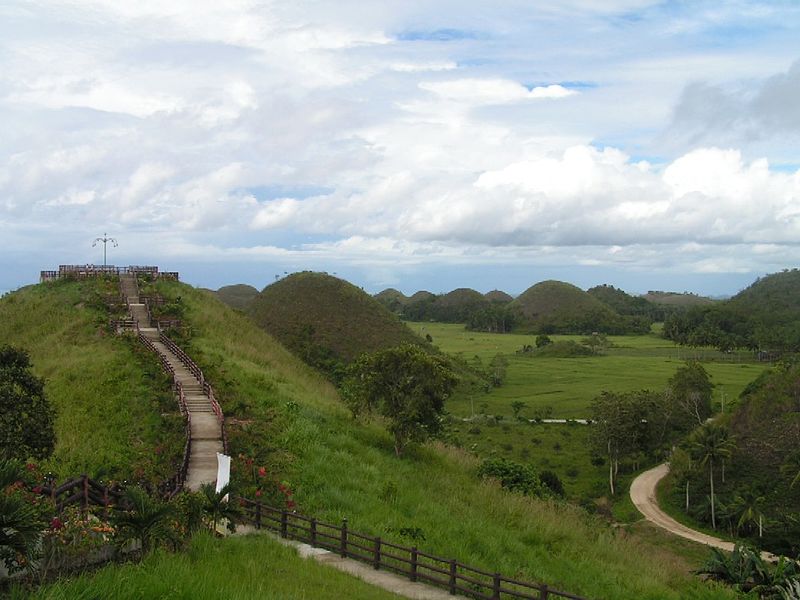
[0,0,800,296]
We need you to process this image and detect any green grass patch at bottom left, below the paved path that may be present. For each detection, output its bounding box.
[17,535,406,600]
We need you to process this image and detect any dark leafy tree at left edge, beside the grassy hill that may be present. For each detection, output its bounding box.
[0,345,55,460]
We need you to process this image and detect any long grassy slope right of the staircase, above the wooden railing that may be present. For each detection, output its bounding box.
[147,282,732,599]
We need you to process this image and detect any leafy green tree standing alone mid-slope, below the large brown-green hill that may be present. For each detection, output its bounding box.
[343,344,458,456]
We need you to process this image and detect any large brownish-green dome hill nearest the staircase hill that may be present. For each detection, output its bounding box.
[248,271,424,370]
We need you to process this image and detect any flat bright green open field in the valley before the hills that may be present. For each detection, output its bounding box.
[416,323,766,418]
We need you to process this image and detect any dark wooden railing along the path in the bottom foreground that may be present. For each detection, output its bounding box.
[235,497,584,600]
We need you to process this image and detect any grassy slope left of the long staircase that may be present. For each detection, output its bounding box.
[0,279,183,481]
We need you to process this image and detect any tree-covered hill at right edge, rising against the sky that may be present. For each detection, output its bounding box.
[664,269,800,353]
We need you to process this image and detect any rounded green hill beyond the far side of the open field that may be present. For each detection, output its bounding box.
[509,280,628,334]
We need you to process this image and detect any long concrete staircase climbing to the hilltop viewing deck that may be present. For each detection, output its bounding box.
[120,275,223,491]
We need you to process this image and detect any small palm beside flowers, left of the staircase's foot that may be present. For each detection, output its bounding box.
[114,487,175,556]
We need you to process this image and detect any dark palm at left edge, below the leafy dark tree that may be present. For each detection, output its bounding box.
[0,459,42,570]
